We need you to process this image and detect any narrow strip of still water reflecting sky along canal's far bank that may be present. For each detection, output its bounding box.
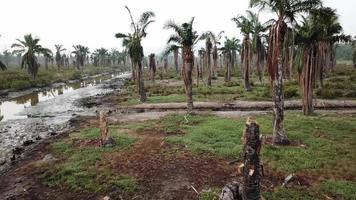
[0,75,115,121]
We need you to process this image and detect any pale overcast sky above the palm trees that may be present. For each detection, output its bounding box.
[0,0,356,53]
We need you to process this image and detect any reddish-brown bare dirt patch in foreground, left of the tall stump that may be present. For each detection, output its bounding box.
[106,132,235,200]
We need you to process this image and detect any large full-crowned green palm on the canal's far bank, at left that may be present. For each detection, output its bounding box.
[11,34,51,79]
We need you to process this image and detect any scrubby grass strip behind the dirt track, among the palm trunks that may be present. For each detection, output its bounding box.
[119,64,356,106]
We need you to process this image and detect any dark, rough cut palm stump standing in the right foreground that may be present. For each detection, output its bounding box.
[220,118,263,200]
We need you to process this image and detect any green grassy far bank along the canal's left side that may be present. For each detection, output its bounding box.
[0,66,119,91]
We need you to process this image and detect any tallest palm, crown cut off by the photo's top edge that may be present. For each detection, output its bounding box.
[250,0,320,144]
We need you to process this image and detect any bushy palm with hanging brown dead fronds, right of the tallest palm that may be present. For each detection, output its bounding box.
[296,7,348,115]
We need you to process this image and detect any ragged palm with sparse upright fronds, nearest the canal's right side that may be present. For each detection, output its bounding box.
[115,6,155,102]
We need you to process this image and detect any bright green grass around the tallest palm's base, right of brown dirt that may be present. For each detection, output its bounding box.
[122,112,356,199]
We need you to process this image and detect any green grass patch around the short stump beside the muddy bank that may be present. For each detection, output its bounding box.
[41,128,137,196]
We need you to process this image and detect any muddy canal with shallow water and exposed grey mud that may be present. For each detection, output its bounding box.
[0,73,130,171]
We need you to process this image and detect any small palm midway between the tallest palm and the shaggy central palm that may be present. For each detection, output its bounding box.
[219,37,241,82]
